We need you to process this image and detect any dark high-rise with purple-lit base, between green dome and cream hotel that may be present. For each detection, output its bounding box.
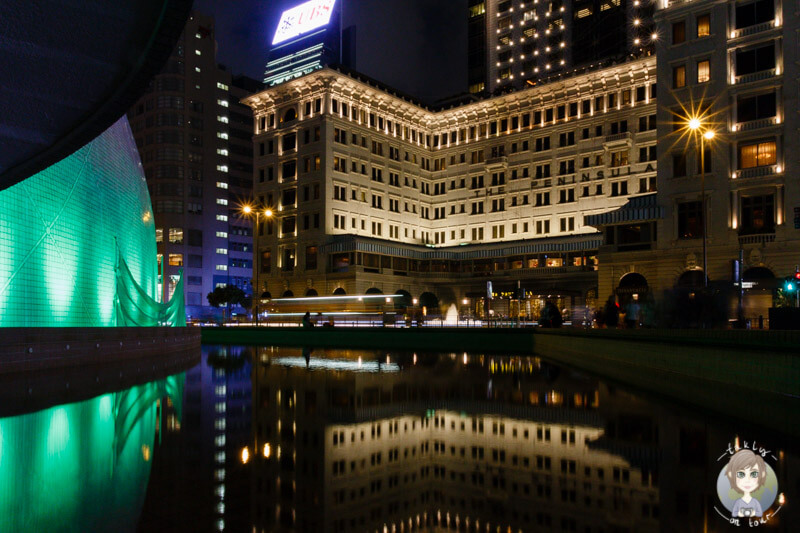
[128,13,261,318]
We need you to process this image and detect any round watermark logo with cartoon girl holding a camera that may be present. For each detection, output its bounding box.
[714,437,784,527]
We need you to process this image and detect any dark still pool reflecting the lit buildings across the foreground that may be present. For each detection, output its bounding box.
[0,346,800,533]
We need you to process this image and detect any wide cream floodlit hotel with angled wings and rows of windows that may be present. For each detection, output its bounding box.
[243,57,659,316]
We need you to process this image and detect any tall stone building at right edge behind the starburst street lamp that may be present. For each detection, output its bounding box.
[600,0,800,324]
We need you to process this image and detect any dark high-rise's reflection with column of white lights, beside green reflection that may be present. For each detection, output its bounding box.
[139,346,251,532]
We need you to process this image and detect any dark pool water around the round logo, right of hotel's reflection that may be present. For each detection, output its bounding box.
[591,383,800,532]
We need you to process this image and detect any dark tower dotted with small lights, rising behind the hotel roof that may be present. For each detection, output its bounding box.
[468,0,658,94]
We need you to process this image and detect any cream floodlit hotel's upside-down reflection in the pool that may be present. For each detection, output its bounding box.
[251,349,659,531]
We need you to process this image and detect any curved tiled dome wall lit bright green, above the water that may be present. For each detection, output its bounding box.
[0,117,158,327]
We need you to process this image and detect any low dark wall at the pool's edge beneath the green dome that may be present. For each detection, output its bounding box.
[0,327,200,417]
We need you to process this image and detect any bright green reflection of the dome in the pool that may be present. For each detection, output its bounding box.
[0,374,184,533]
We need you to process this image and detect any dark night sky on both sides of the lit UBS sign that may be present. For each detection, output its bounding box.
[195,0,467,102]
